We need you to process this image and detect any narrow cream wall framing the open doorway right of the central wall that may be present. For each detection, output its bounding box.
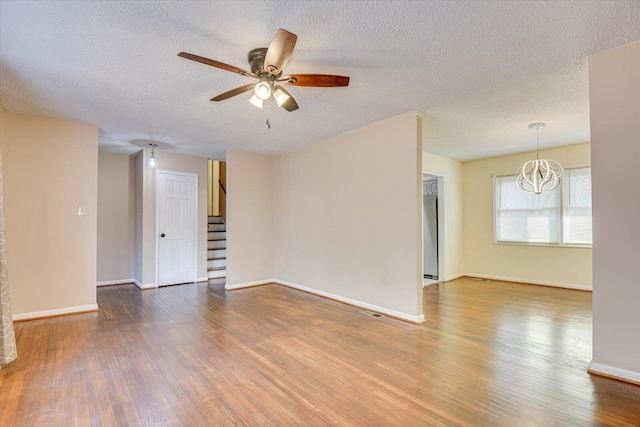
[422,151,465,280]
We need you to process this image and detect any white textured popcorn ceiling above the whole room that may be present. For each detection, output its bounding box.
[0,0,640,160]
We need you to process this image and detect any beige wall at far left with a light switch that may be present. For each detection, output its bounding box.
[0,112,98,317]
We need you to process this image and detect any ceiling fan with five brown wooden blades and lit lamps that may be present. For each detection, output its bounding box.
[178,28,349,111]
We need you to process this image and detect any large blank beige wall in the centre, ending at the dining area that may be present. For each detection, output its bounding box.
[272,112,422,320]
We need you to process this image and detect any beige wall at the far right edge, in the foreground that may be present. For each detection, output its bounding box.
[589,42,640,383]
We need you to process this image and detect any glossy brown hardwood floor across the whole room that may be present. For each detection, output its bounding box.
[0,279,640,427]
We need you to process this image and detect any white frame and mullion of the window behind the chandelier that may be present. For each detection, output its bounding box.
[492,165,593,249]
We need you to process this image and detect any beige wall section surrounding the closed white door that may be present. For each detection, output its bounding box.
[134,150,207,287]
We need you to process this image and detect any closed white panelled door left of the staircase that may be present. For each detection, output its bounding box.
[156,171,198,286]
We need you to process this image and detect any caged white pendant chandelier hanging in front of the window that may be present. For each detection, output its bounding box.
[517,123,562,194]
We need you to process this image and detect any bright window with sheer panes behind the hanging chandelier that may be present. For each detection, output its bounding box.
[494,168,592,246]
